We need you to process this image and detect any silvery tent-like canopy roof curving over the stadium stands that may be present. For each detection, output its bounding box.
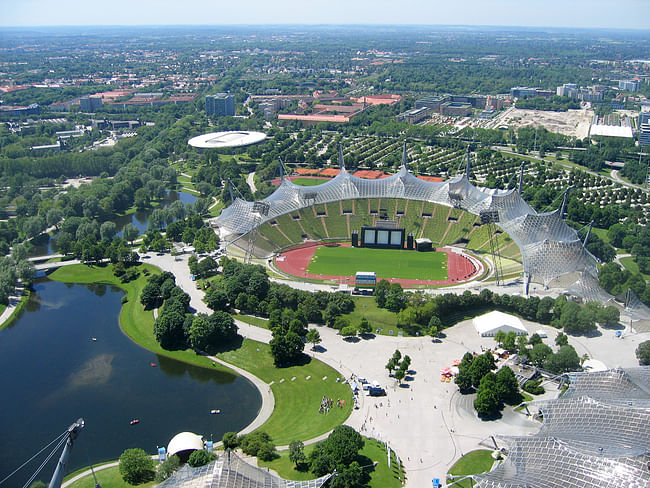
[212,152,598,287]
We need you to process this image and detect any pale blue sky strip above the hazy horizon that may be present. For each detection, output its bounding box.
[0,0,650,29]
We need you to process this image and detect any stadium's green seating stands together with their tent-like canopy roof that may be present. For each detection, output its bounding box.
[213,144,636,302]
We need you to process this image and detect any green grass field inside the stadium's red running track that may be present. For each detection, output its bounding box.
[307,246,447,280]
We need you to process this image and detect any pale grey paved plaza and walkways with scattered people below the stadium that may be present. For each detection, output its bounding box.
[145,254,650,487]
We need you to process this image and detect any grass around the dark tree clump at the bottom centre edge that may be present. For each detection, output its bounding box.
[256,437,404,488]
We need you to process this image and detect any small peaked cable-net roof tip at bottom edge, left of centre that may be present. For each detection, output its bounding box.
[158,452,332,488]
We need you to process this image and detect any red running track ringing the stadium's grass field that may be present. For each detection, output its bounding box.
[275,243,484,287]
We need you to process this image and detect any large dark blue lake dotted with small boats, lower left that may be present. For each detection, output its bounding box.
[0,278,262,488]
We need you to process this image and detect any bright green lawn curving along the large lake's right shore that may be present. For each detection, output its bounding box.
[50,264,352,445]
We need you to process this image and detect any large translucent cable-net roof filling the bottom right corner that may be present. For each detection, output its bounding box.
[472,367,650,488]
